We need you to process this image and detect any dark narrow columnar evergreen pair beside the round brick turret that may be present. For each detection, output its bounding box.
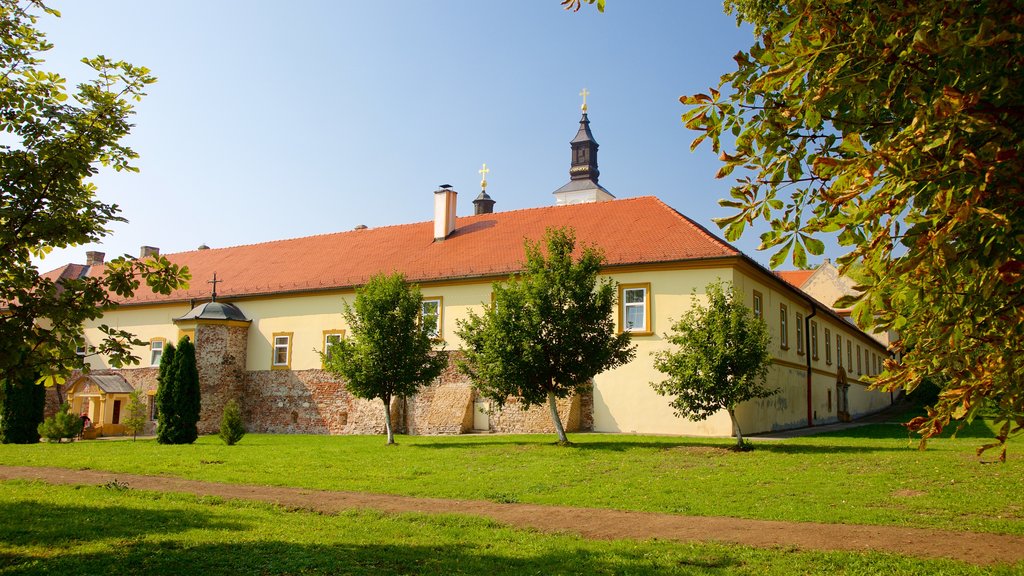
[157,336,202,444]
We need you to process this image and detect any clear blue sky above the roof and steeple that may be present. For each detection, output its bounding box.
[39,0,806,270]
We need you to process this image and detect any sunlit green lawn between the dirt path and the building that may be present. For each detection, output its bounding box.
[0,416,1024,534]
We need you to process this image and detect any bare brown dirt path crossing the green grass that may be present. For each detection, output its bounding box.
[0,466,1024,565]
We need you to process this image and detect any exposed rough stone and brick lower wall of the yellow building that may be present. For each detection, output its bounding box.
[77,350,593,435]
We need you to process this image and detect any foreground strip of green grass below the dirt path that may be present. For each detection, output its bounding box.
[0,482,1024,576]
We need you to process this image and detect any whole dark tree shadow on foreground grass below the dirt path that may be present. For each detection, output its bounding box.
[0,491,740,576]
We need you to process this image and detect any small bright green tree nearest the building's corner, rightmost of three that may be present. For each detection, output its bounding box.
[651,282,778,449]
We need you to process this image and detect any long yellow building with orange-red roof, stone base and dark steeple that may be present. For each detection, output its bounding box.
[51,114,891,436]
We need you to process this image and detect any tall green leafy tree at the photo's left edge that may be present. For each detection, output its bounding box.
[0,0,189,400]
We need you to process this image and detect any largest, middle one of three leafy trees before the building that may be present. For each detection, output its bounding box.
[458,229,636,444]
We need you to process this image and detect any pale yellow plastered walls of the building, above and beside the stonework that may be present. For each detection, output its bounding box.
[85,258,890,436]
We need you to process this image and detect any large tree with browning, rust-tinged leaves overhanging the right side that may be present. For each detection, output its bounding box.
[681,0,1024,459]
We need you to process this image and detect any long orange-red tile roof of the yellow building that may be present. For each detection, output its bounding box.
[49,197,739,303]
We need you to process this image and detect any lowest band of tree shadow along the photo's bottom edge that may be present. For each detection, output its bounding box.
[0,541,738,576]
